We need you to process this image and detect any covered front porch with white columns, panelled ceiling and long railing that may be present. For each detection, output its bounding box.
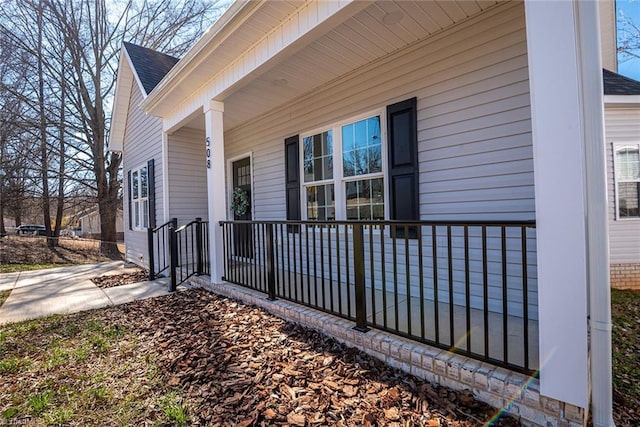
[142,1,600,422]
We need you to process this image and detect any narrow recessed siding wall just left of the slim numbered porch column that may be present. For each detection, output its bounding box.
[168,128,209,224]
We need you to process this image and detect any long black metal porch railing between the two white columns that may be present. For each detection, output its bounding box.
[220,221,539,373]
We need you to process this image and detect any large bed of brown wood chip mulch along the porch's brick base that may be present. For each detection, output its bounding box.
[110,290,520,427]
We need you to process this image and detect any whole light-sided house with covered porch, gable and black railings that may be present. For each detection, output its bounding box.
[109,0,613,425]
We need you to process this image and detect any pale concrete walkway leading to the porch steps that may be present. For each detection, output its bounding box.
[0,261,169,325]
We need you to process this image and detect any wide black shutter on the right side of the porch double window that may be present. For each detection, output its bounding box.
[387,98,420,221]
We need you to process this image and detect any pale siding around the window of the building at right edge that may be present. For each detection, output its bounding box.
[605,106,640,264]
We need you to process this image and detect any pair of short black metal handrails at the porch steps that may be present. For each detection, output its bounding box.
[147,218,210,291]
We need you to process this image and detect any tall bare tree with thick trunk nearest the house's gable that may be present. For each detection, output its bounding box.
[0,0,224,252]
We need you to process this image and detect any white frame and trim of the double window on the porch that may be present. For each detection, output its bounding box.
[298,108,389,221]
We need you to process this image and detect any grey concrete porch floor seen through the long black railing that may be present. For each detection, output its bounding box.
[219,262,539,371]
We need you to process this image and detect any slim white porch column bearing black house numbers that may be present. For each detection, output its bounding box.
[204,101,227,283]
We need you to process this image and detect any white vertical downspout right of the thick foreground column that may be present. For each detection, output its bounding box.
[574,0,615,427]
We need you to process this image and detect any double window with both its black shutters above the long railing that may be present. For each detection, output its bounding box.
[285,98,419,221]
